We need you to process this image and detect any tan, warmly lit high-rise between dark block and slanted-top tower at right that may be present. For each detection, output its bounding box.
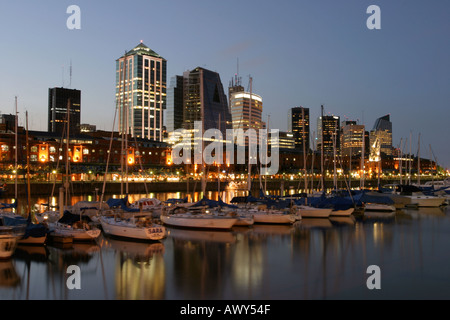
[341,121,365,156]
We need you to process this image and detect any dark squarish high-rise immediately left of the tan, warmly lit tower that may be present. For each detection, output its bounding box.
[317,116,341,154]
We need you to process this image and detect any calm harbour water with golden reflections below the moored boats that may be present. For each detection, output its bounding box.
[0,194,450,300]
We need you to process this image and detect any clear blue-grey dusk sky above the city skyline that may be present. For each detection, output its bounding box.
[0,0,450,168]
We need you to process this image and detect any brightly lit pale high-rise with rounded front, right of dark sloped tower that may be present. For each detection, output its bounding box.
[229,80,266,146]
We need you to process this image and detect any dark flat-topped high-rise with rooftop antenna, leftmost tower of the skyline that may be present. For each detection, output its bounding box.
[48,87,81,135]
